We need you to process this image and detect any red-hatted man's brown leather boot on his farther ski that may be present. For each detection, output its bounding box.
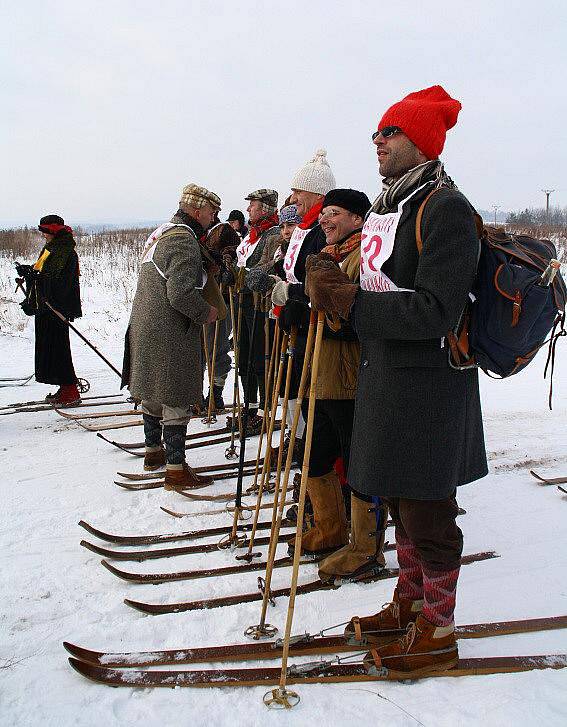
[344,588,423,644]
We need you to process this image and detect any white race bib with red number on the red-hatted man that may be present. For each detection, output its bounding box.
[360,184,426,293]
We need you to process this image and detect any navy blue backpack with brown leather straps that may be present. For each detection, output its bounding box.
[416,190,567,406]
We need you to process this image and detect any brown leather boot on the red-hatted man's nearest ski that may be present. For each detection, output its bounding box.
[364,614,459,678]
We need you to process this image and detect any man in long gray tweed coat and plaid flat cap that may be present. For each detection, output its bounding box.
[123,184,221,489]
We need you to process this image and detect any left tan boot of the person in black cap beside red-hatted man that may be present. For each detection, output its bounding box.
[301,470,348,555]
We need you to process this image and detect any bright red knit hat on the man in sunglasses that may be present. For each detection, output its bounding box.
[378,86,462,159]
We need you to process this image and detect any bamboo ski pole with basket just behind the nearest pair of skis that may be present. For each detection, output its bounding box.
[244,316,315,640]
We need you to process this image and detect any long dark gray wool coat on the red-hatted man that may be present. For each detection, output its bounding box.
[349,189,488,500]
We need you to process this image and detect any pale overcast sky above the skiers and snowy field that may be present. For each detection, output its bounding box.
[0,0,567,226]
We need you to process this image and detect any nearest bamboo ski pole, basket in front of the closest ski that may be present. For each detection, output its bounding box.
[264,311,325,709]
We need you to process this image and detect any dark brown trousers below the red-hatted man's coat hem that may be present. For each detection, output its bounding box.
[382,493,463,571]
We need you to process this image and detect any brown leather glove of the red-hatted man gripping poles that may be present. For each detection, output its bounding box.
[305,255,359,320]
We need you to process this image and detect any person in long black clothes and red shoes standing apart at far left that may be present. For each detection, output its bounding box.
[22,215,82,406]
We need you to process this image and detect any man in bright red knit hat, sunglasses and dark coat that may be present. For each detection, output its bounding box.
[307,86,487,676]
